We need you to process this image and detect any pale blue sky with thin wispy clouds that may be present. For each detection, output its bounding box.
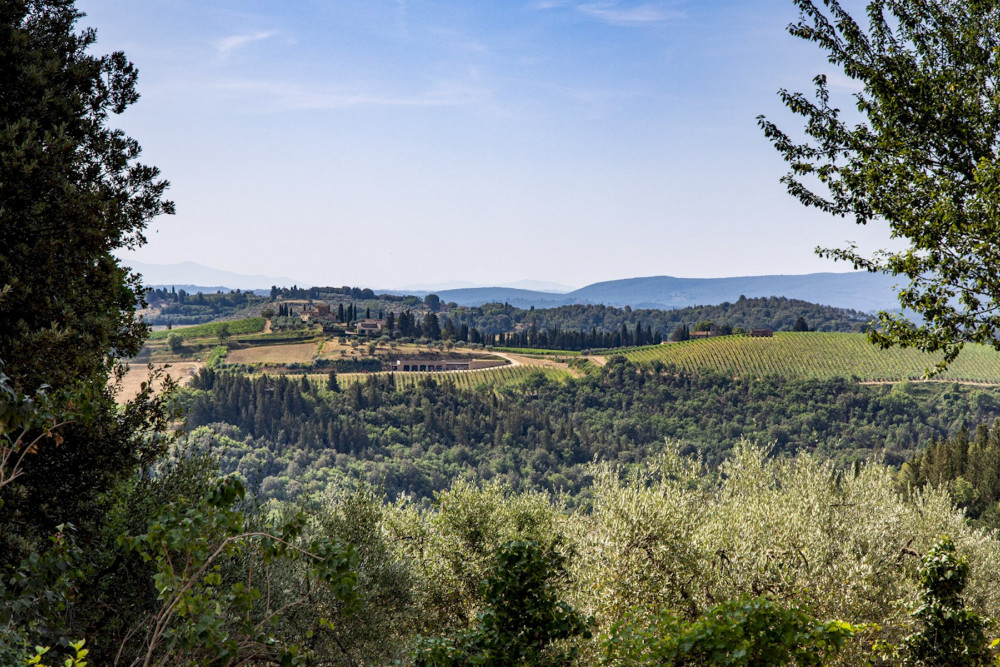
[78,0,900,287]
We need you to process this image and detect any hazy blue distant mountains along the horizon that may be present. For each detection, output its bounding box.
[128,261,899,312]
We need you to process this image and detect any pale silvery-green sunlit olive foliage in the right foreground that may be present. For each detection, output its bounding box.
[567,444,1000,664]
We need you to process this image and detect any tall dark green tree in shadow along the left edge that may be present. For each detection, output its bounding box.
[0,0,174,562]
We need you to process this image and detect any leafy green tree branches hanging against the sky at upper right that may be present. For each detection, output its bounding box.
[758,0,1000,369]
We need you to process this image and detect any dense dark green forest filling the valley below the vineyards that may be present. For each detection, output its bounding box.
[177,357,1000,499]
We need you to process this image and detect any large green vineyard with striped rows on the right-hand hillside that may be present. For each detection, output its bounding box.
[623,332,1000,384]
